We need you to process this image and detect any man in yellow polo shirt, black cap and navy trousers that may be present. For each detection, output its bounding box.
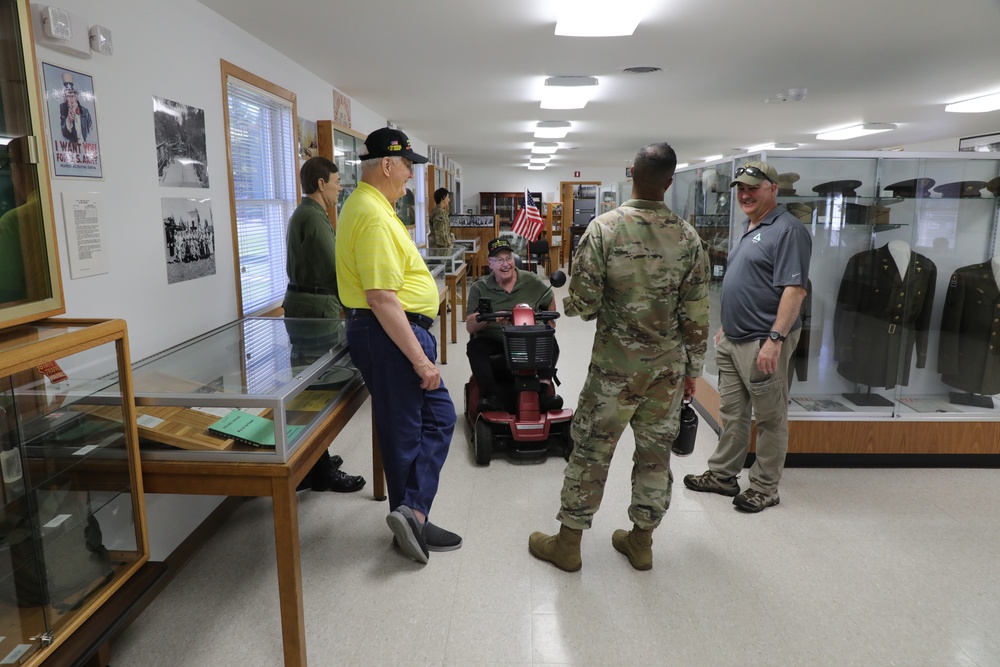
[337,127,462,563]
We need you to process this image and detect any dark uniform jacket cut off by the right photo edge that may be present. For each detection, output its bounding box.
[938,262,1000,395]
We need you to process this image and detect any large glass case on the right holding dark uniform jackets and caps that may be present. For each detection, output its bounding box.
[675,151,1000,428]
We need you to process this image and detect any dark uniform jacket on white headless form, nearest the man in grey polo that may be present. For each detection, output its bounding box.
[833,245,937,389]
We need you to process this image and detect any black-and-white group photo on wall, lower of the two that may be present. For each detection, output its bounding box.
[161,197,215,285]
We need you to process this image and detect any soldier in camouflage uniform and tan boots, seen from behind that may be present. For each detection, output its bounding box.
[528,143,709,572]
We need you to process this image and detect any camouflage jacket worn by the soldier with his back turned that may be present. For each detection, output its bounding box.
[563,199,710,377]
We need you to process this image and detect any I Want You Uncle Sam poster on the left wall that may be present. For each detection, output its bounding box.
[42,63,104,178]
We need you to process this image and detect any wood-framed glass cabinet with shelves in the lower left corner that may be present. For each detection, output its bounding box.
[0,320,149,665]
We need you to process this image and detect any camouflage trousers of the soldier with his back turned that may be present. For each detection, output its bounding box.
[556,361,684,529]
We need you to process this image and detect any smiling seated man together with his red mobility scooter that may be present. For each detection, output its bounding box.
[465,238,572,464]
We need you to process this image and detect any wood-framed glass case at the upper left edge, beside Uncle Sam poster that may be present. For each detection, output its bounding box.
[0,0,65,328]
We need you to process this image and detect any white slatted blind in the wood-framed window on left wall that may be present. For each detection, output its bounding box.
[226,76,296,315]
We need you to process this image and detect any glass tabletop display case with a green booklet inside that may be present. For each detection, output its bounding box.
[118,317,362,463]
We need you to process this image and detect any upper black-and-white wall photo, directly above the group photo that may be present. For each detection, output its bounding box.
[153,96,208,188]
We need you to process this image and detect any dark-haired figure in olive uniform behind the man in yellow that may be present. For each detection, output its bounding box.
[281,157,365,493]
